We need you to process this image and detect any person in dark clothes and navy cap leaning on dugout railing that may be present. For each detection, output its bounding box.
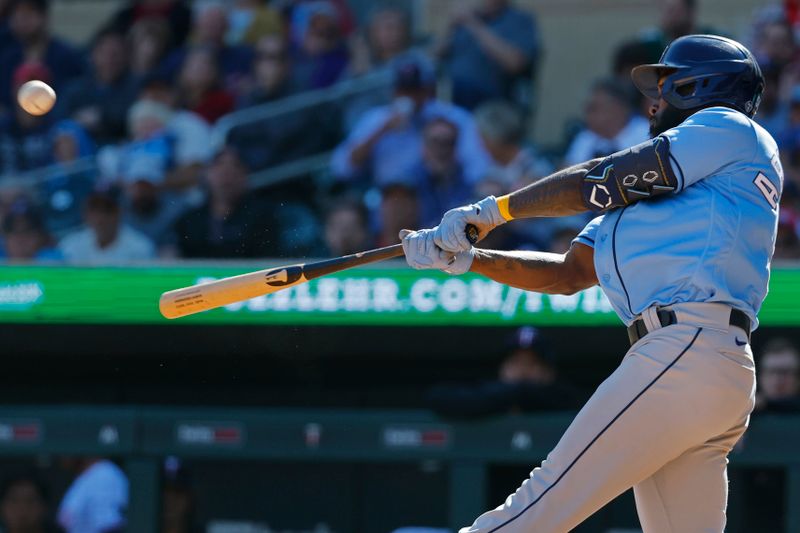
[427,327,584,417]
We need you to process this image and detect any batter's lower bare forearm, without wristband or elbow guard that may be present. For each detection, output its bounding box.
[470,248,583,294]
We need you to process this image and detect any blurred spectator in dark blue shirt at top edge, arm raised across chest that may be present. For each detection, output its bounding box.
[436,0,541,110]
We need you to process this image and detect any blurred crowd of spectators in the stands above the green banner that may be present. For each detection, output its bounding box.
[0,0,800,264]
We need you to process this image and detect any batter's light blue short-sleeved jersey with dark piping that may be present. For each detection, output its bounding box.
[575,107,783,329]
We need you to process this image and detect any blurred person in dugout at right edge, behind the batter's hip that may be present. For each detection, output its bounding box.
[756,338,800,413]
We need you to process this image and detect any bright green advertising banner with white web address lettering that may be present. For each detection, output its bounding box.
[0,266,800,326]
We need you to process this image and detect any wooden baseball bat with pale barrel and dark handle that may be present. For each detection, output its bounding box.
[158,224,478,318]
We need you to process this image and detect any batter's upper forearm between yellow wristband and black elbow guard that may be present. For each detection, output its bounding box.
[508,159,600,218]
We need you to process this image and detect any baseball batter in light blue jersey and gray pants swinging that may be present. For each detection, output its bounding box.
[403,35,783,533]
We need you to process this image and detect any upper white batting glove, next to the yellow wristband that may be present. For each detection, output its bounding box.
[433,196,506,252]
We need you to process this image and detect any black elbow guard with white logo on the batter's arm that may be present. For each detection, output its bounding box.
[583,136,678,211]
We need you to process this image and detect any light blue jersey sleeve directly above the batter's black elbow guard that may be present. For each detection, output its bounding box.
[662,107,758,191]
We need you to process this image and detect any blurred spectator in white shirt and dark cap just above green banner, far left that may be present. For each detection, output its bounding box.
[58,185,155,264]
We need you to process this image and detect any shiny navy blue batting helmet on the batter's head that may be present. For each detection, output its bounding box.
[631,35,764,117]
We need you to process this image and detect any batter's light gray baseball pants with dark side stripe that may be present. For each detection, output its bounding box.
[460,303,756,533]
